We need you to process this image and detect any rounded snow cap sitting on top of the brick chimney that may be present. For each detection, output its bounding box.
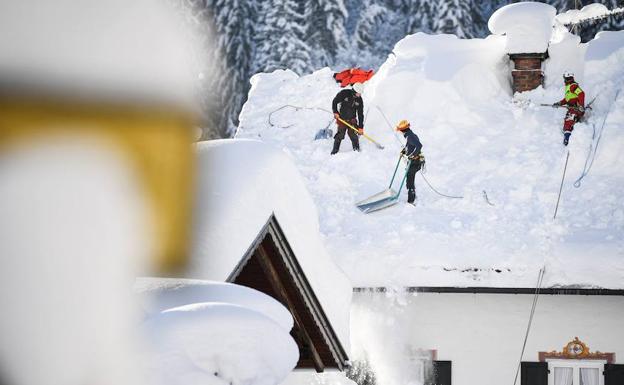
[488,2,557,54]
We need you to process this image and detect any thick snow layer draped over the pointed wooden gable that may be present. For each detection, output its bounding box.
[189,139,352,351]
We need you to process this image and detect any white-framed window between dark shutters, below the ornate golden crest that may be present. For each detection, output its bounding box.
[546,359,607,385]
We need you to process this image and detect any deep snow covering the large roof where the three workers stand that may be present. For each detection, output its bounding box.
[237,30,624,288]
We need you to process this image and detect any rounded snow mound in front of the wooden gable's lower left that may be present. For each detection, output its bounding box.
[136,278,299,385]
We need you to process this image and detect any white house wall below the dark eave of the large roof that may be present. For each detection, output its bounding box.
[351,292,624,385]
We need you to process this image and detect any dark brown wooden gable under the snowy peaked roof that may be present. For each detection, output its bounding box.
[227,215,348,372]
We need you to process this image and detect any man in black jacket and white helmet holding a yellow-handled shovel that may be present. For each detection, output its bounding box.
[331,83,364,155]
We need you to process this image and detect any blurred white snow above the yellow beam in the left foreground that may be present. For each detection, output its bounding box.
[0,0,197,107]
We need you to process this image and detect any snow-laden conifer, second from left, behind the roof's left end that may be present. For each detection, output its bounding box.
[254,0,312,74]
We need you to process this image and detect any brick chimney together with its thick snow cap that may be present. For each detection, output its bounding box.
[488,2,557,92]
